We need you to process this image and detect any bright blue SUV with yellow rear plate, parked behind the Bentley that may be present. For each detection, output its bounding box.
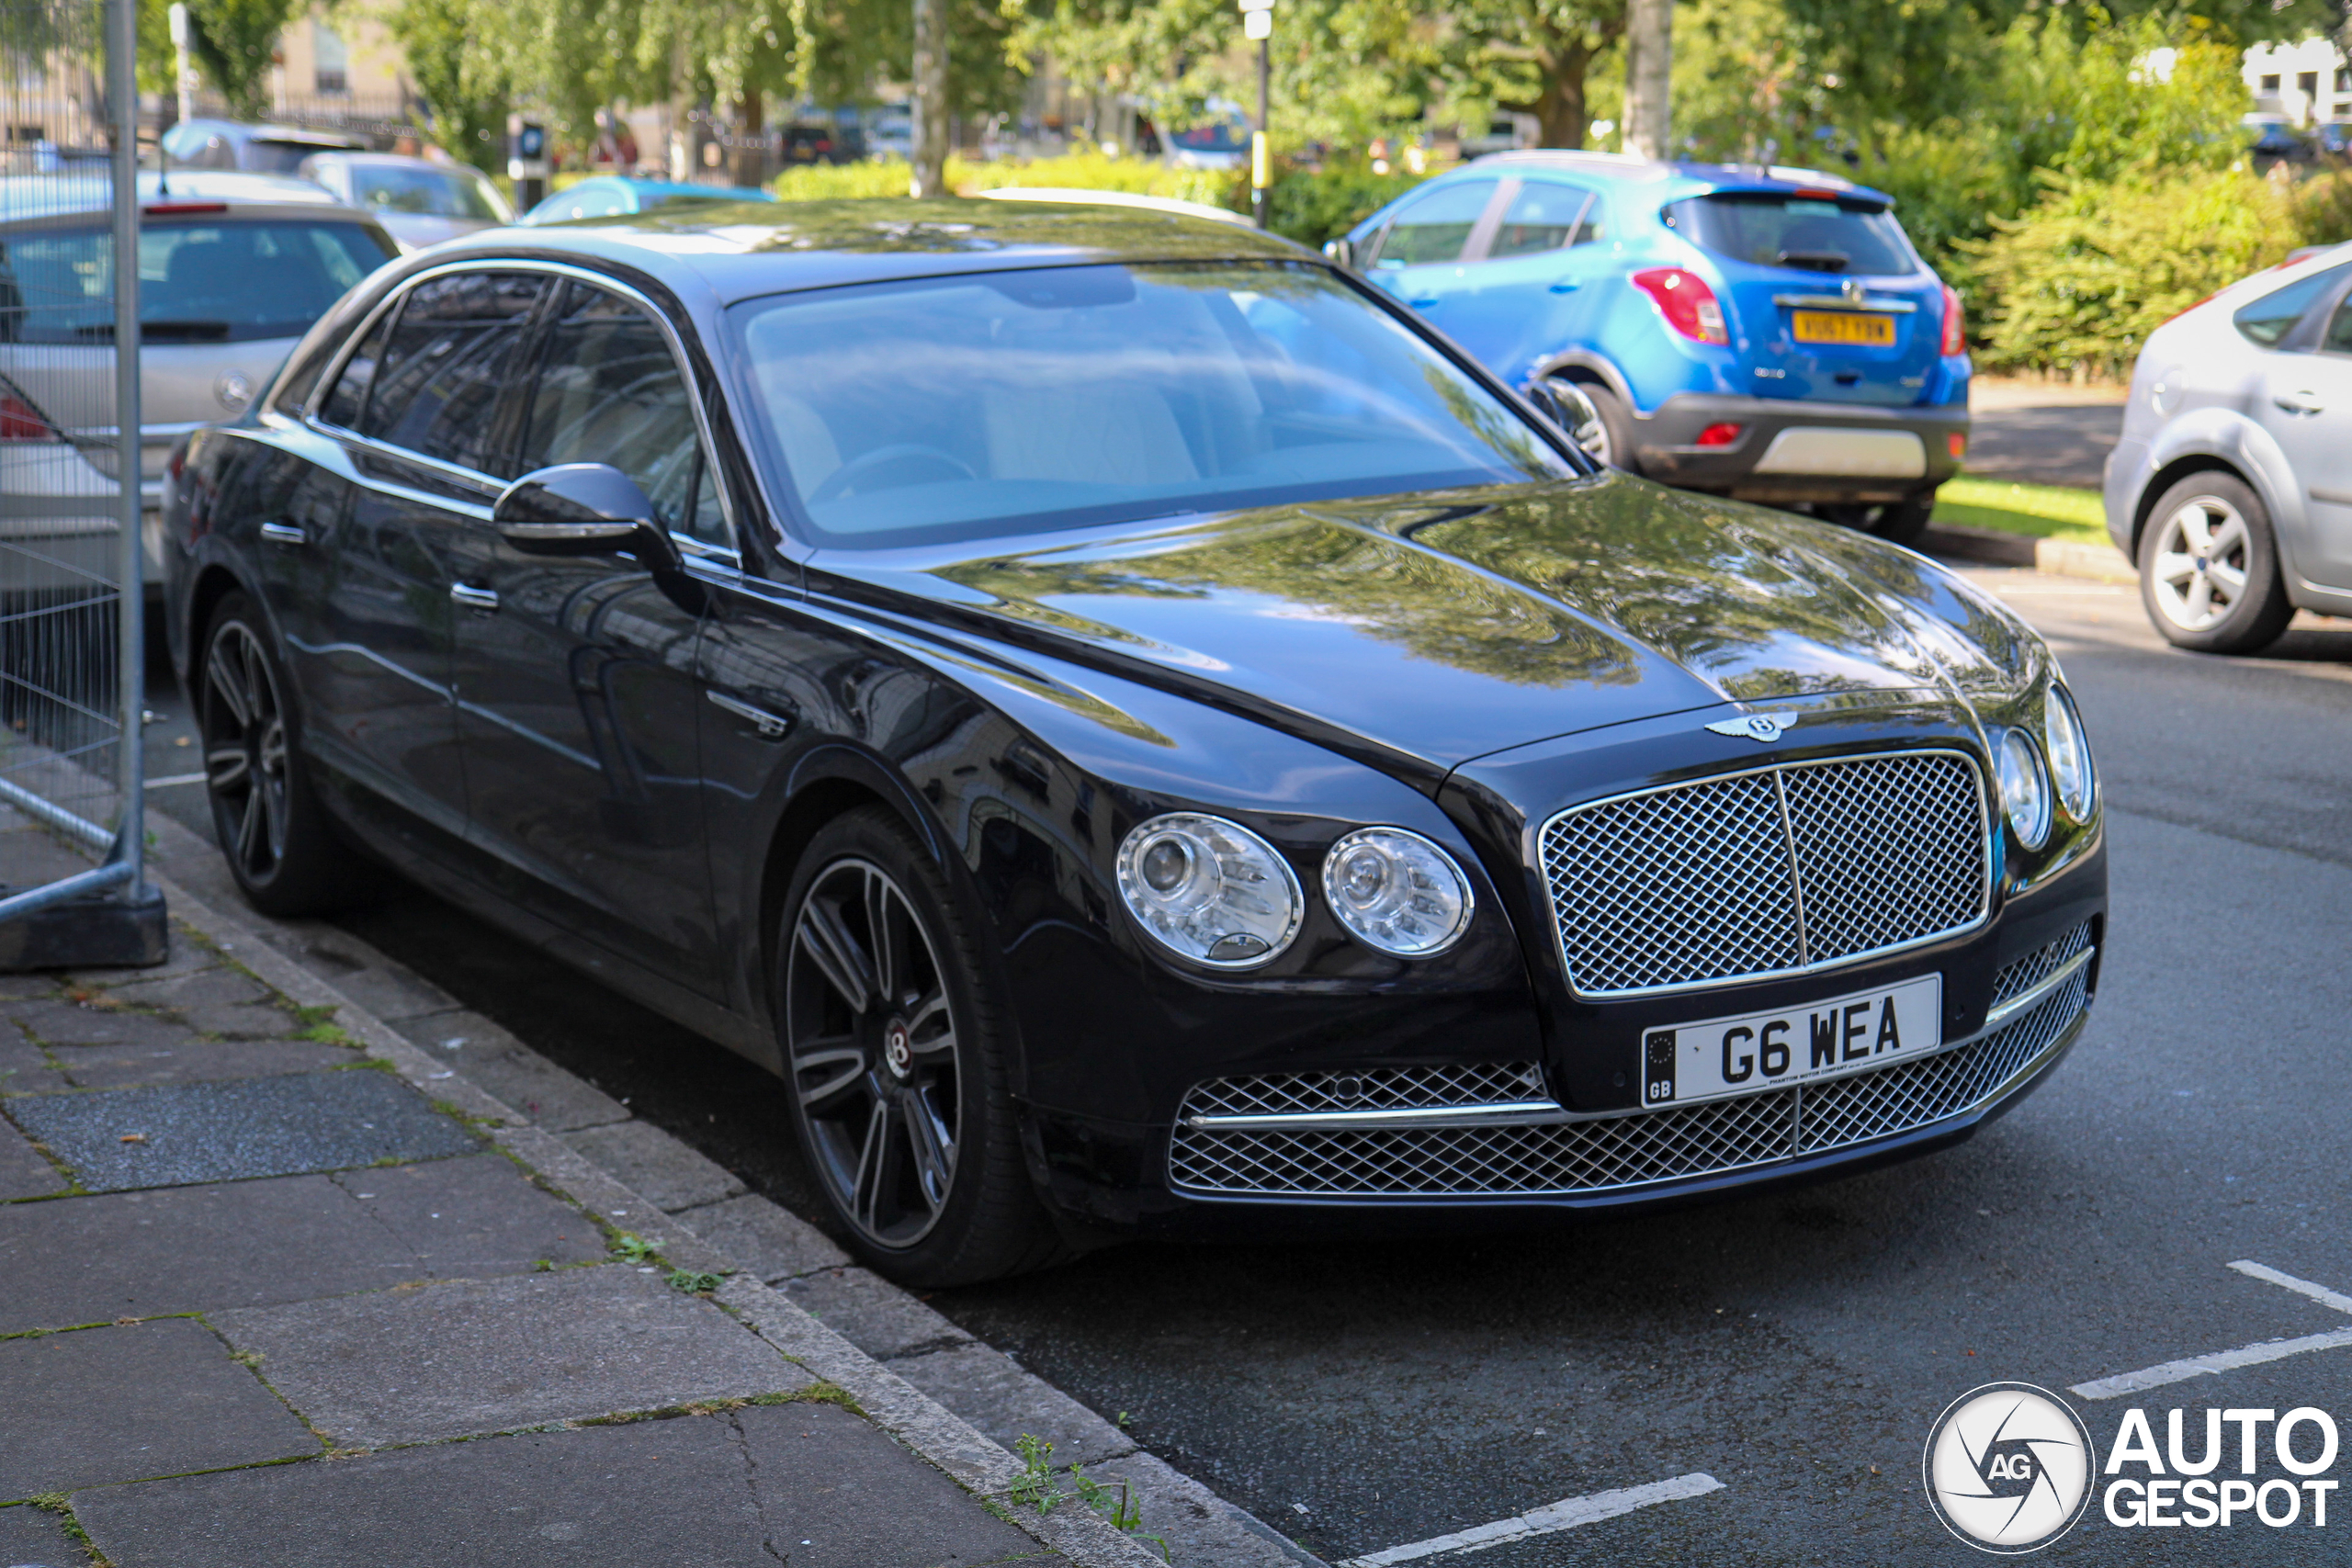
[1327,152,1969,543]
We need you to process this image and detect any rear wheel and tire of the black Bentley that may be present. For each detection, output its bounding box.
[188,592,379,915]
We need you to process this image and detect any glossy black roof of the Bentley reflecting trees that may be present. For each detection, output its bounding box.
[421,197,1322,306]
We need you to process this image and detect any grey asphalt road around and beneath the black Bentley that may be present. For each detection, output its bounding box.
[151,569,2352,1568]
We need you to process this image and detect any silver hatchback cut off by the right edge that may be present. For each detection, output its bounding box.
[2105,244,2352,653]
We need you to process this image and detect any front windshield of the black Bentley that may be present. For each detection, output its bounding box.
[729,264,1576,547]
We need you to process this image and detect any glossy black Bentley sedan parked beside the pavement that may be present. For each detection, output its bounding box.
[167,202,2108,1283]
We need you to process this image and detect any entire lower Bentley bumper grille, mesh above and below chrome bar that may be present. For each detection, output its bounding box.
[1169,926,2091,1197]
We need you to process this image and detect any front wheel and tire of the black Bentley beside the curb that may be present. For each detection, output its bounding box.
[772,807,1063,1286]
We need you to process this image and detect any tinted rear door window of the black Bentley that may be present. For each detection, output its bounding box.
[359,273,546,479]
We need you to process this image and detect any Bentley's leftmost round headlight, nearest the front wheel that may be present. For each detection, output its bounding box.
[1120,811,1306,968]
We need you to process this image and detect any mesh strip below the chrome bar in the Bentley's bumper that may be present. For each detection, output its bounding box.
[1169,974,2088,1197]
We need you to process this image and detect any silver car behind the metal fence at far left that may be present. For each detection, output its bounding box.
[0,169,400,587]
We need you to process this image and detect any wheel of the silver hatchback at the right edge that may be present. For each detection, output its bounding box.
[2141,470,2296,653]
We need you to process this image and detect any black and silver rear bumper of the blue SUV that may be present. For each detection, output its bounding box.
[1633,392,1969,503]
